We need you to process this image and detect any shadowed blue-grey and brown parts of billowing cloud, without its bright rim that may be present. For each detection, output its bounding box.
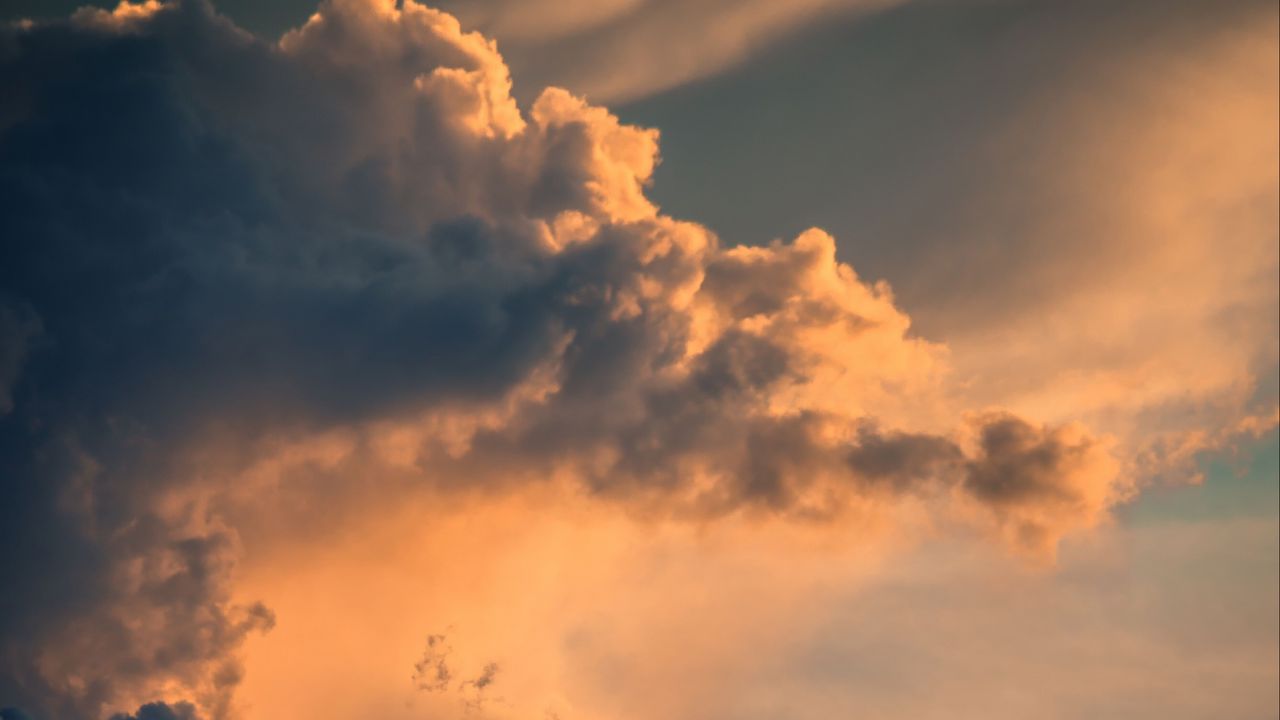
[0,1,1121,720]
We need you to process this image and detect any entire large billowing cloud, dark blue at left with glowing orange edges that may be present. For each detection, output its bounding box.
[0,0,1269,720]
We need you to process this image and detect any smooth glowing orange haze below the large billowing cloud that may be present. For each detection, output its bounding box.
[230,474,1277,720]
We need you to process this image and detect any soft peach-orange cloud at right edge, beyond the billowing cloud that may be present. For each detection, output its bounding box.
[929,4,1280,477]
